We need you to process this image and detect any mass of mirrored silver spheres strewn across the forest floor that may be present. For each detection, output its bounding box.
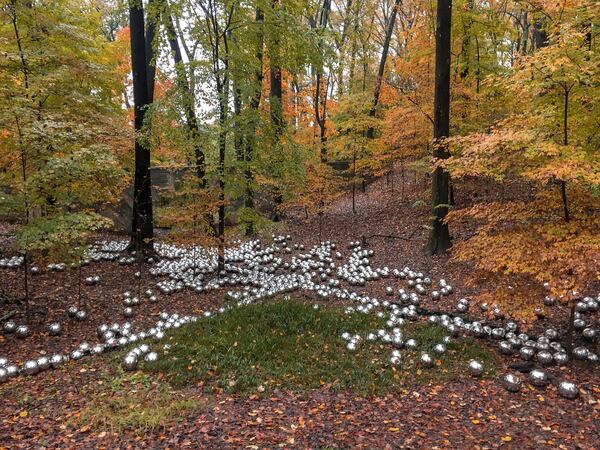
[0,236,599,398]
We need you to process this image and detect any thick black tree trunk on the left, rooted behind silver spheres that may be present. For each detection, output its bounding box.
[129,0,154,252]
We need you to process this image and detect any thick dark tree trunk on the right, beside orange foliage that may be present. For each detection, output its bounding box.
[424,0,452,255]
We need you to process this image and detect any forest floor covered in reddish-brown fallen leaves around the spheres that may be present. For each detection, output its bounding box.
[0,174,600,449]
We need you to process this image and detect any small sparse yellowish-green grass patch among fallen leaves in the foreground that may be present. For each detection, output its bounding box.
[77,372,203,434]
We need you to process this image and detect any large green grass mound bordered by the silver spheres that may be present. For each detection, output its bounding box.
[144,300,494,394]
